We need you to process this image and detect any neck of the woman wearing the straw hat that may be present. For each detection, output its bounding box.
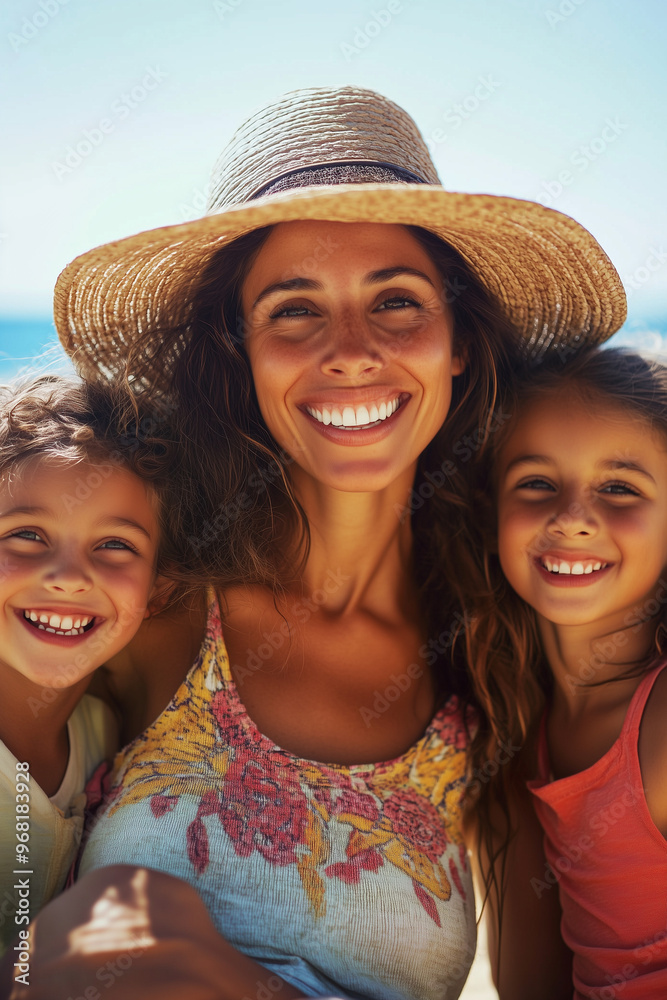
[294,468,415,616]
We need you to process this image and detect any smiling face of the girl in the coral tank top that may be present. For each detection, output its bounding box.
[497,391,667,632]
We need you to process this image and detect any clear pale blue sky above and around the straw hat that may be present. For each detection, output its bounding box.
[0,0,667,317]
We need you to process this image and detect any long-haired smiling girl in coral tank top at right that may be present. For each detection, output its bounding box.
[469,350,667,1000]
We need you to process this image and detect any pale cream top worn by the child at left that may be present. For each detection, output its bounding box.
[0,694,118,954]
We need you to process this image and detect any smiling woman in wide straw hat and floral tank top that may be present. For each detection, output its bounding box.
[3,88,624,998]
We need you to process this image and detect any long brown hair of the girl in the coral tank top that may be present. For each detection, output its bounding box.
[461,348,667,920]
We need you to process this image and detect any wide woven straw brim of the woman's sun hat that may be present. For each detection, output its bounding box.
[54,183,626,376]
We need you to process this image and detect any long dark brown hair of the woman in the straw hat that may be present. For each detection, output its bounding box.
[127,226,518,699]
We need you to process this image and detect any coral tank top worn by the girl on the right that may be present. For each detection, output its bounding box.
[528,663,667,1000]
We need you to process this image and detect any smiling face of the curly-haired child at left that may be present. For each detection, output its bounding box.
[0,459,158,688]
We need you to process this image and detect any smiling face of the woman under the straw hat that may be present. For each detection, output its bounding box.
[242,221,463,492]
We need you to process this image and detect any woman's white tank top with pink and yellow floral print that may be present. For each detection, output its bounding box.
[80,599,476,1000]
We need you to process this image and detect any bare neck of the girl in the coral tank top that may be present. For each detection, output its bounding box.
[538,615,656,718]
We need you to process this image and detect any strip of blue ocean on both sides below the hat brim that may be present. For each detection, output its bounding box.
[0,306,667,383]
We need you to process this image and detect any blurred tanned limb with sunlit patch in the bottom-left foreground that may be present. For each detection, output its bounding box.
[0,865,299,1000]
